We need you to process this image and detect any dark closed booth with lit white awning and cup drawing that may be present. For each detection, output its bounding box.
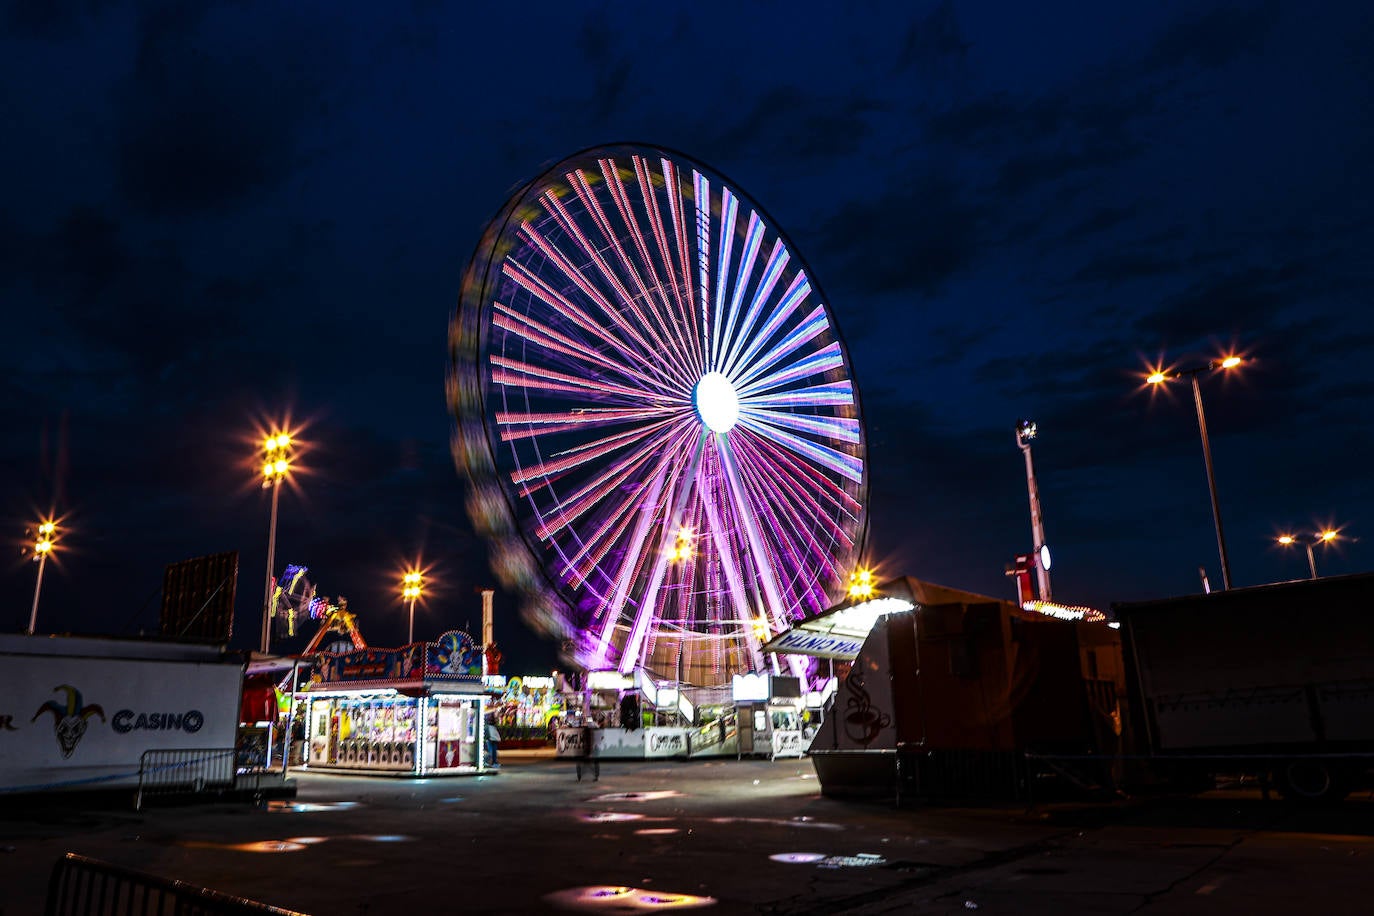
[769,577,1125,801]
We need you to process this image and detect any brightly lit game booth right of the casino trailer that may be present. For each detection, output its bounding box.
[297,630,492,776]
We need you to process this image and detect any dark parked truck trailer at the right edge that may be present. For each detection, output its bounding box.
[1112,574,1374,801]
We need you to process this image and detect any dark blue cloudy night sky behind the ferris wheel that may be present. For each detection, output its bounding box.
[0,0,1374,672]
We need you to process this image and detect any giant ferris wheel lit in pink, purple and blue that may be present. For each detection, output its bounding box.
[449,146,867,684]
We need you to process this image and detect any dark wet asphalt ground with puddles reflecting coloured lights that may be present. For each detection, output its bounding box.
[0,753,1374,916]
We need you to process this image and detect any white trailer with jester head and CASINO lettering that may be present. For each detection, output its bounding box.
[0,634,245,792]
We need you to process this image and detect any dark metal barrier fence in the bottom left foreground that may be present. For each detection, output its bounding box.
[43,853,306,916]
